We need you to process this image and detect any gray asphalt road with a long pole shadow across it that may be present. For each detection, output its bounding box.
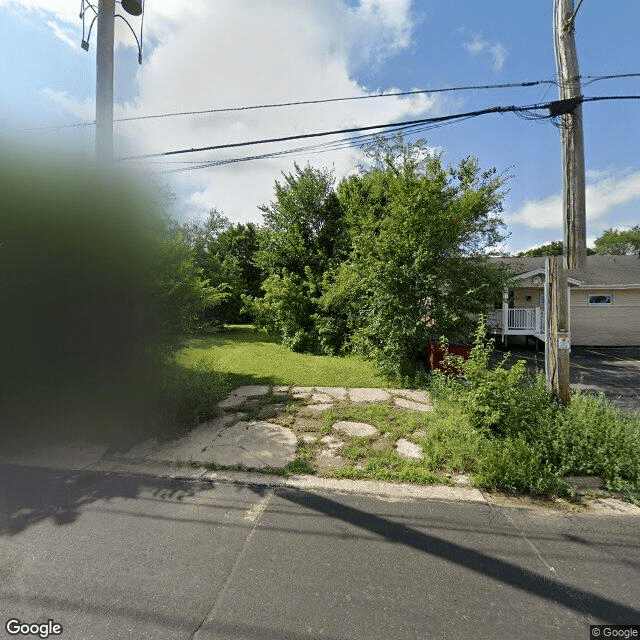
[0,466,640,640]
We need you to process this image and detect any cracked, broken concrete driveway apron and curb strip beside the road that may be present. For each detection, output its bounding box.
[0,385,640,515]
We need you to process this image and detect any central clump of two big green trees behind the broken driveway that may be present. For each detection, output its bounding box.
[248,137,507,375]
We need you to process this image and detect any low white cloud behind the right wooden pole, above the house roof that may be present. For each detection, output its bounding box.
[509,170,640,229]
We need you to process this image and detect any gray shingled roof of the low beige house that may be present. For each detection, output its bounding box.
[492,254,640,287]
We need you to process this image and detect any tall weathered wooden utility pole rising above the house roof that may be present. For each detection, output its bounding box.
[553,0,587,269]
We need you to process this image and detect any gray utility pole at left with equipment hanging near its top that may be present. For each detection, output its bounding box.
[96,0,116,163]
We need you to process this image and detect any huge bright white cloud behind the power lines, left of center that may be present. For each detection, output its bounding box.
[7,0,449,221]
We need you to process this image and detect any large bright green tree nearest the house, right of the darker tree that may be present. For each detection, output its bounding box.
[336,137,508,376]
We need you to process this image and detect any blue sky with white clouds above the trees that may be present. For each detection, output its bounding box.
[0,0,640,252]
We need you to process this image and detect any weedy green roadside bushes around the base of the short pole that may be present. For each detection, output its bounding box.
[426,323,640,495]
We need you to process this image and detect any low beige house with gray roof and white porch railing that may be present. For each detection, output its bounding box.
[489,255,640,347]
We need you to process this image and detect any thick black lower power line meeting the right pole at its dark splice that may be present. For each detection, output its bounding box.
[119,96,640,160]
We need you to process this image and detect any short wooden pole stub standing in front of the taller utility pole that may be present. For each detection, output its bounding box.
[544,256,571,406]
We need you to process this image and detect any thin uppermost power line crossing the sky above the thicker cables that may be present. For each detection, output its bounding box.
[20,73,640,131]
